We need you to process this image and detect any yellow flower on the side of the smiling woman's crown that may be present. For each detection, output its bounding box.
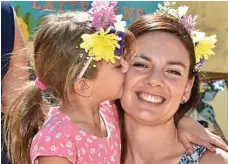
[195,35,217,63]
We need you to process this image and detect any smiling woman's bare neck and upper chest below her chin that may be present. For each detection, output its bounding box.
[125,115,185,164]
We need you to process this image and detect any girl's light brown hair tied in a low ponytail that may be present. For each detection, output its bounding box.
[4,12,134,164]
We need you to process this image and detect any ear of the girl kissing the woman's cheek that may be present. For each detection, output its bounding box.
[74,78,93,97]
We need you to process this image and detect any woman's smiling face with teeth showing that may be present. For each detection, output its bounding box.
[121,32,194,124]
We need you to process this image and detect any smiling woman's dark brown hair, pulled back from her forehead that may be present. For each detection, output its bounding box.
[116,14,199,163]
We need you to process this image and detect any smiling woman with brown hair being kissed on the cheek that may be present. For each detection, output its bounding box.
[121,11,228,164]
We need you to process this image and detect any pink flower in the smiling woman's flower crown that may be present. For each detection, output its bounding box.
[181,15,198,32]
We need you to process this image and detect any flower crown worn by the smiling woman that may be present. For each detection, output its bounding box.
[155,2,217,72]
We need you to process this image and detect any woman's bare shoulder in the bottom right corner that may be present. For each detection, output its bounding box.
[199,148,228,164]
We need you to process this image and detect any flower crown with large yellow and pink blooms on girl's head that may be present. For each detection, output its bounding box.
[77,1,126,78]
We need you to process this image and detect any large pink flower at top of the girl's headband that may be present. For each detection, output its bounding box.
[89,1,117,30]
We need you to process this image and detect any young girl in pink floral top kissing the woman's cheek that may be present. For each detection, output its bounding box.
[6,2,228,164]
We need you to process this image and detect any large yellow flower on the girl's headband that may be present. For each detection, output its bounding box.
[80,28,121,64]
